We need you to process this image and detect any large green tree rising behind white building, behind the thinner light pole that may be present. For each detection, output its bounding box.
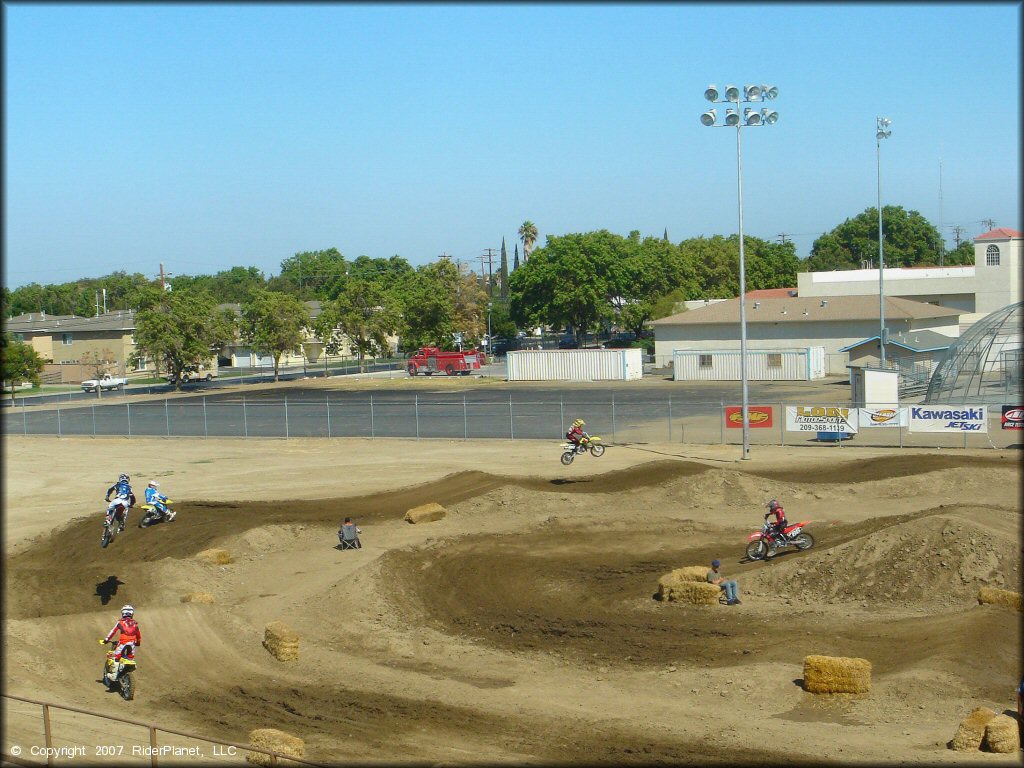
[806,206,941,271]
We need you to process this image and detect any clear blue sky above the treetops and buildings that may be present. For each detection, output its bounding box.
[3,2,1021,288]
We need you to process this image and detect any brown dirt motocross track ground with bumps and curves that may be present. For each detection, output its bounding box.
[3,438,1022,765]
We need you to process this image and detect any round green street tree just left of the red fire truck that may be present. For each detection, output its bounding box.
[313,280,401,370]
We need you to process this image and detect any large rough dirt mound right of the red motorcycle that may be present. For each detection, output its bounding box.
[751,507,1020,607]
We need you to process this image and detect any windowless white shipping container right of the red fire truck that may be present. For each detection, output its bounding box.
[507,348,643,381]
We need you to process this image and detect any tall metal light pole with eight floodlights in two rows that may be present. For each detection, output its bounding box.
[700,85,778,459]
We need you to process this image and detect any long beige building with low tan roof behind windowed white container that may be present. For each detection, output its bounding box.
[651,294,963,376]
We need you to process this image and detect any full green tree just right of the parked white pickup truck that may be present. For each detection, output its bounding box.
[135,292,236,388]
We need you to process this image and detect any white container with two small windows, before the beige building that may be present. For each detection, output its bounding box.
[672,347,825,381]
